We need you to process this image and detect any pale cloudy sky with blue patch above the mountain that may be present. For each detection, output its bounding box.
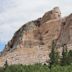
[0,0,72,51]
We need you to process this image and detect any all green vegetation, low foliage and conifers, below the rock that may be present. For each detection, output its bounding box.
[0,40,72,72]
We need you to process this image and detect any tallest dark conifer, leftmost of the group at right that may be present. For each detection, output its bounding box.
[49,40,59,66]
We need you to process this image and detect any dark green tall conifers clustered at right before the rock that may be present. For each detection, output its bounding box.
[49,40,72,67]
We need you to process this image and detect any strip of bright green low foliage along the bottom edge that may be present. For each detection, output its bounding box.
[0,64,72,72]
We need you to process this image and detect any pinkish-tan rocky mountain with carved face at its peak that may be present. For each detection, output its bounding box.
[0,7,72,66]
